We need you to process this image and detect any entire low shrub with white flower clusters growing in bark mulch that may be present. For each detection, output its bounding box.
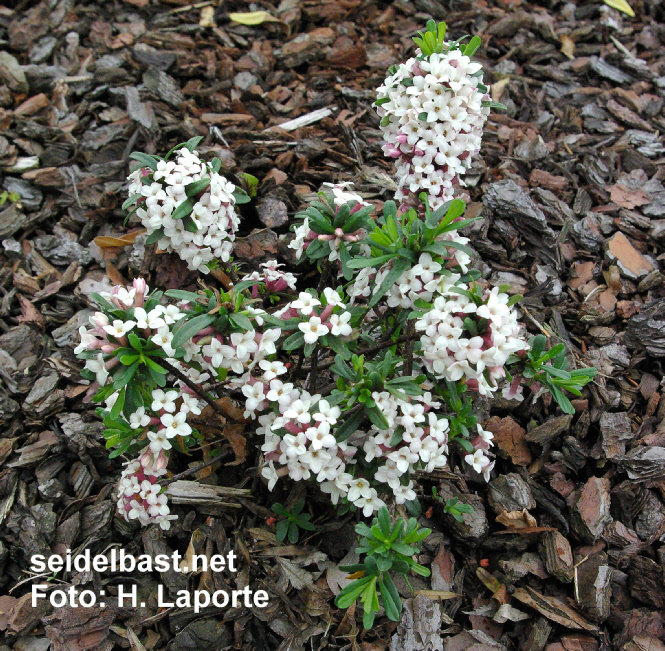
[76,22,595,621]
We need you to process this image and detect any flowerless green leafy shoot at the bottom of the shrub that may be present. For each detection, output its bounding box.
[335,506,431,629]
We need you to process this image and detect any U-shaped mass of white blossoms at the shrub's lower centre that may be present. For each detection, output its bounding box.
[257,388,456,516]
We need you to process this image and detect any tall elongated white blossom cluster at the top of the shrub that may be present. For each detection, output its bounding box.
[377,50,490,209]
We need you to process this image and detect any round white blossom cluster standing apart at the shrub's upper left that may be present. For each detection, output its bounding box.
[129,147,239,273]
